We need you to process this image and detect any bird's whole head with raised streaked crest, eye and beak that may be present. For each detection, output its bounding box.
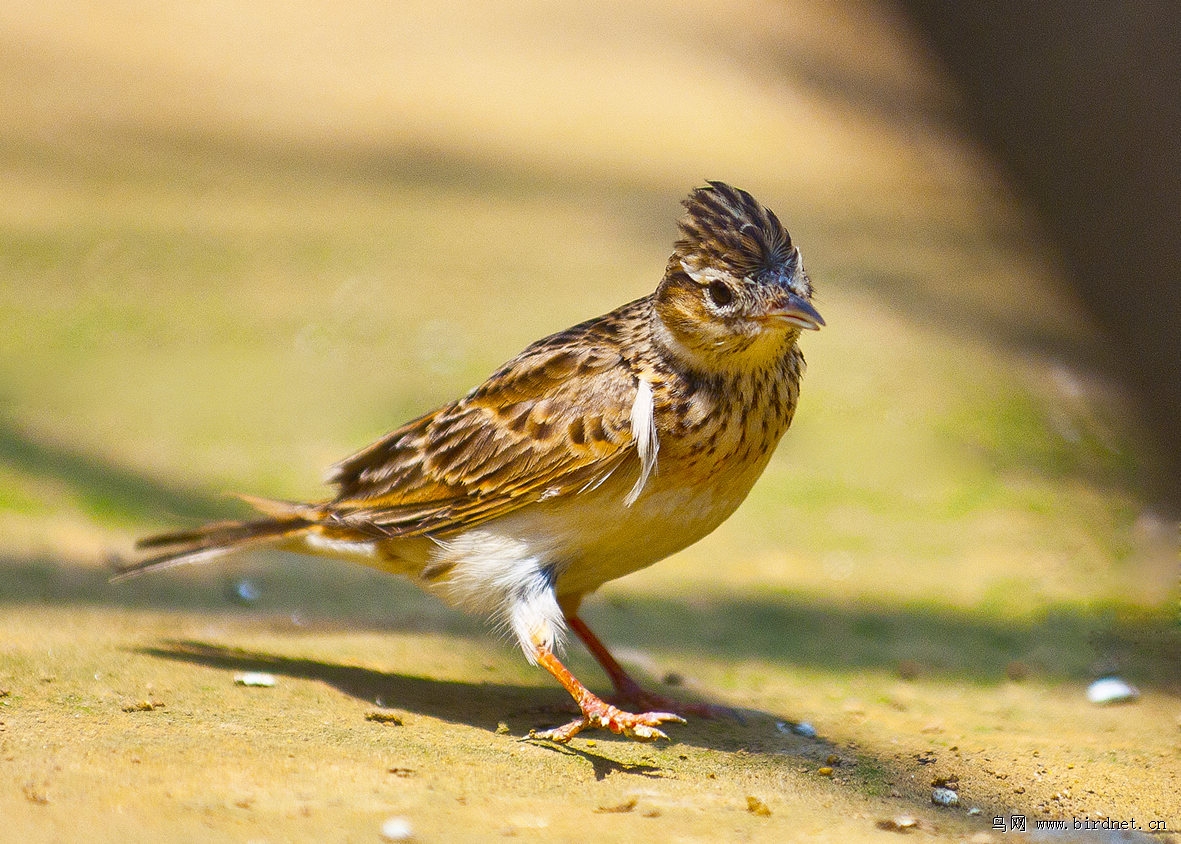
[655,182,824,368]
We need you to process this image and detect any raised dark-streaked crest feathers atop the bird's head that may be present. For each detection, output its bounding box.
[672,182,796,279]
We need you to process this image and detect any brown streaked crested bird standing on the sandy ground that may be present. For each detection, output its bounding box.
[116,181,824,742]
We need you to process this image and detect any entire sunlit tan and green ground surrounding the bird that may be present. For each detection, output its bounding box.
[0,0,1181,844]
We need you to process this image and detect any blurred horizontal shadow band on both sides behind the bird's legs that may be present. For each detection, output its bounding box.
[0,554,1181,694]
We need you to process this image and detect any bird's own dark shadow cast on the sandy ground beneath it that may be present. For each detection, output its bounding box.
[136,640,812,779]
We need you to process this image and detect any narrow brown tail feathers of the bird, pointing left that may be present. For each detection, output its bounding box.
[112,496,315,580]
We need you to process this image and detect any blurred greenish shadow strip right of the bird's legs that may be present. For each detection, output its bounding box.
[585,593,1181,694]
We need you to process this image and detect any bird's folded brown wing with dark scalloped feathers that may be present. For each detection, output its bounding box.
[321,329,637,536]
